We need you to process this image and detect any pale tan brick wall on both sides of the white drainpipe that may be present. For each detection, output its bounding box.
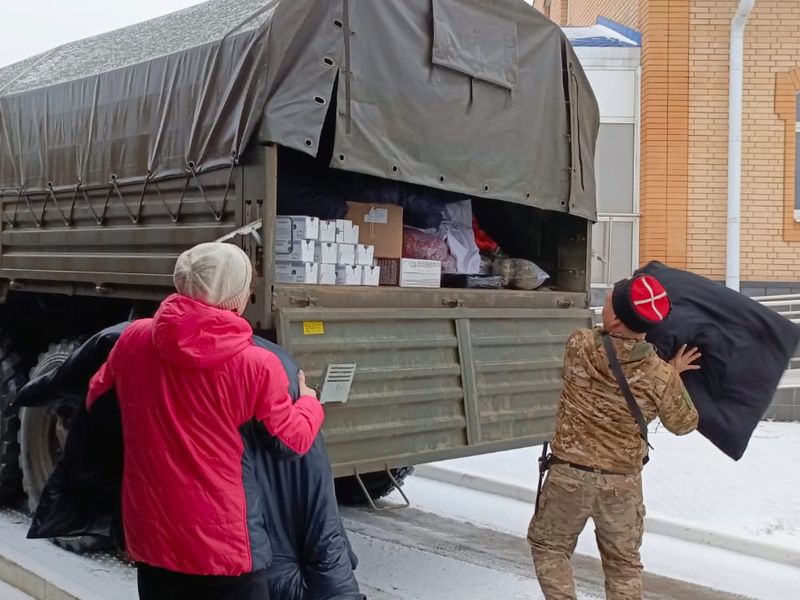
[687,0,800,281]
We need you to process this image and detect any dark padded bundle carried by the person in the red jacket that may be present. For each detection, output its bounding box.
[16,323,362,600]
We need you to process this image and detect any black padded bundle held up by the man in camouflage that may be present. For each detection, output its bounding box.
[636,261,800,460]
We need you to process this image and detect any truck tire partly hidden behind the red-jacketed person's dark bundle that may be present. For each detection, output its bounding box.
[19,340,111,553]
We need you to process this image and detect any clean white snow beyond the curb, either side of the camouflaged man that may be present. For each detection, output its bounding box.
[432,423,800,551]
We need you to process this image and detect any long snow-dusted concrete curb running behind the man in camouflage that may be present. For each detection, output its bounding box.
[415,465,800,568]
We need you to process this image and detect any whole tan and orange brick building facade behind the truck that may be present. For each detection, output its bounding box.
[534,0,800,294]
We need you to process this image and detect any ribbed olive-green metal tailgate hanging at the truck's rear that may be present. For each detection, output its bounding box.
[277,309,588,474]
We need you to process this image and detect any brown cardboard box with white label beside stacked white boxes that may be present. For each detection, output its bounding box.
[347,202,403,258]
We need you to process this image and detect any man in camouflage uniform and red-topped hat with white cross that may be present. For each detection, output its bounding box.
[528,275,700,600]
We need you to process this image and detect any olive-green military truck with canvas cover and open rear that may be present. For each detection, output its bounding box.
[0,0,599,507]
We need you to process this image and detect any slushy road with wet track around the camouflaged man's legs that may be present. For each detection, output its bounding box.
[343,508,743,600]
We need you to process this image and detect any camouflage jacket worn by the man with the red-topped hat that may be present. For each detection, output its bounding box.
[552,329,698,473]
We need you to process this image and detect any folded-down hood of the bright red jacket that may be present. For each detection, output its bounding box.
[153,294,253,369]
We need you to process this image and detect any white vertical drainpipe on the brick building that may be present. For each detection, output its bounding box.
[725,0,756,292]
